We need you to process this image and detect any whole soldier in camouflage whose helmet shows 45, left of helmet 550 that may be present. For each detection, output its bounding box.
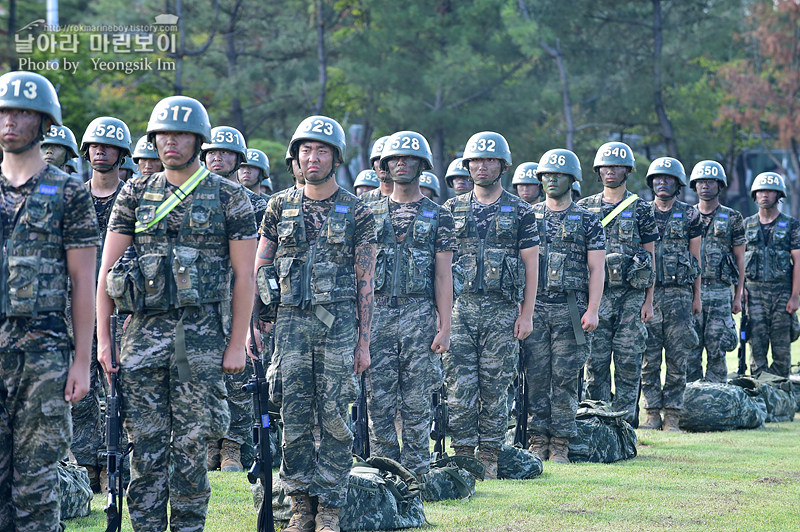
[641,157,703,431]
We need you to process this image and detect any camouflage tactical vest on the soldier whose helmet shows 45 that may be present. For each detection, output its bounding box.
[651,201,700,286]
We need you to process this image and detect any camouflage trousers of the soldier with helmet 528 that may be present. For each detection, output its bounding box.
[366,298,442,475]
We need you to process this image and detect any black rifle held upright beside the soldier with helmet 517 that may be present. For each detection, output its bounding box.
[105,313,133,532]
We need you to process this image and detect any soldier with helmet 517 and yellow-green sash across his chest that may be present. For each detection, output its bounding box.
[97,96,257,531]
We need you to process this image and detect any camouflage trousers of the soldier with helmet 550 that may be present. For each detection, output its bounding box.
[686,281,737,383]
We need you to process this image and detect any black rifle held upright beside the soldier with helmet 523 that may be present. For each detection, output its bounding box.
[242,319,275,532]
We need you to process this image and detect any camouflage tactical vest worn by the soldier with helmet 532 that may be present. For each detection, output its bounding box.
[453,190,525,303]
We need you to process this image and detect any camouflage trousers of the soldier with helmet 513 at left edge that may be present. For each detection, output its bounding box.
[0,350,72,532]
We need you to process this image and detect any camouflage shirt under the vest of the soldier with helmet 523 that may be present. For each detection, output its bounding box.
[261,189,376,247]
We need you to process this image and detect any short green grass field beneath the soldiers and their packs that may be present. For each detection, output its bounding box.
[67,345,800,532]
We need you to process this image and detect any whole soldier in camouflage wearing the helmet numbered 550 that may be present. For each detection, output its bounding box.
[686,161,745,383]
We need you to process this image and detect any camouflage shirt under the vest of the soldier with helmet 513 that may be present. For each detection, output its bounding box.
[0,165,100,351]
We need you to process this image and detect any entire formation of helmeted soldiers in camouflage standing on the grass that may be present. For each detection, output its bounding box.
[0,72,800,532]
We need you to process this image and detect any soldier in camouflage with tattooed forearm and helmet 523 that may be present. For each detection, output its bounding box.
[256,116,375,532]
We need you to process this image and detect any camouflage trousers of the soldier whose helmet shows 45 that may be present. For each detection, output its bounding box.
[642,286,698,410]
